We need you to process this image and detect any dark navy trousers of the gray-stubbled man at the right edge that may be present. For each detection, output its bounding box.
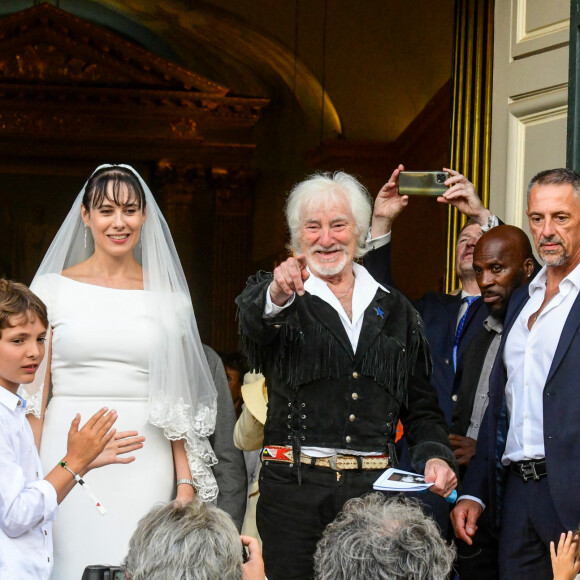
[499,473,573,580]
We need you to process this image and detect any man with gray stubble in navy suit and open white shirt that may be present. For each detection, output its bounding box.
[452,169,580,580]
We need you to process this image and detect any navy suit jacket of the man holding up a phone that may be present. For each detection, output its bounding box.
[364,244,488,425]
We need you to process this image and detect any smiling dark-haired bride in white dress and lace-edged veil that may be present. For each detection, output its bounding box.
[19,165,217,580]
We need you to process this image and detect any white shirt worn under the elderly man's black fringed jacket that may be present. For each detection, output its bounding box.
[264,263,389,457]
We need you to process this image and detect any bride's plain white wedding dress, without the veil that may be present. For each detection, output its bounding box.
[35,274,175,580]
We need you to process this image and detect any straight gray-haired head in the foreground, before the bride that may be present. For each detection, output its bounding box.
[123,500,242,580]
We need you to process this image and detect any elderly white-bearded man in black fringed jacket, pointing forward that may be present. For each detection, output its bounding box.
[237,172,457,580]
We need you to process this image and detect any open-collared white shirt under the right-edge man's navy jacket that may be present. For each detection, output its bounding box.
[502,265,580,465]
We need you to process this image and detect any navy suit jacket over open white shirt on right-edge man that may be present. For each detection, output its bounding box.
[462,286,580,530]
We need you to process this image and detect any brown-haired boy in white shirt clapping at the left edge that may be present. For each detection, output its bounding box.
[0,280,143,580]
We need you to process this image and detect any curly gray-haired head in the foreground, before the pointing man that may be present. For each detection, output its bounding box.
[314,493,455,580]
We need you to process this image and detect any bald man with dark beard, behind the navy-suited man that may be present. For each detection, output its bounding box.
[449,225,535,580]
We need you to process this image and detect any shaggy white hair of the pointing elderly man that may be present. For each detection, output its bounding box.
[286,171,372,258]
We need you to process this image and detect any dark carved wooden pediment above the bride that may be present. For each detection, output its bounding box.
[0,4,269,159]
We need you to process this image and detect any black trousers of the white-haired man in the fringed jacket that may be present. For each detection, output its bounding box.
[256,461,381,580]
